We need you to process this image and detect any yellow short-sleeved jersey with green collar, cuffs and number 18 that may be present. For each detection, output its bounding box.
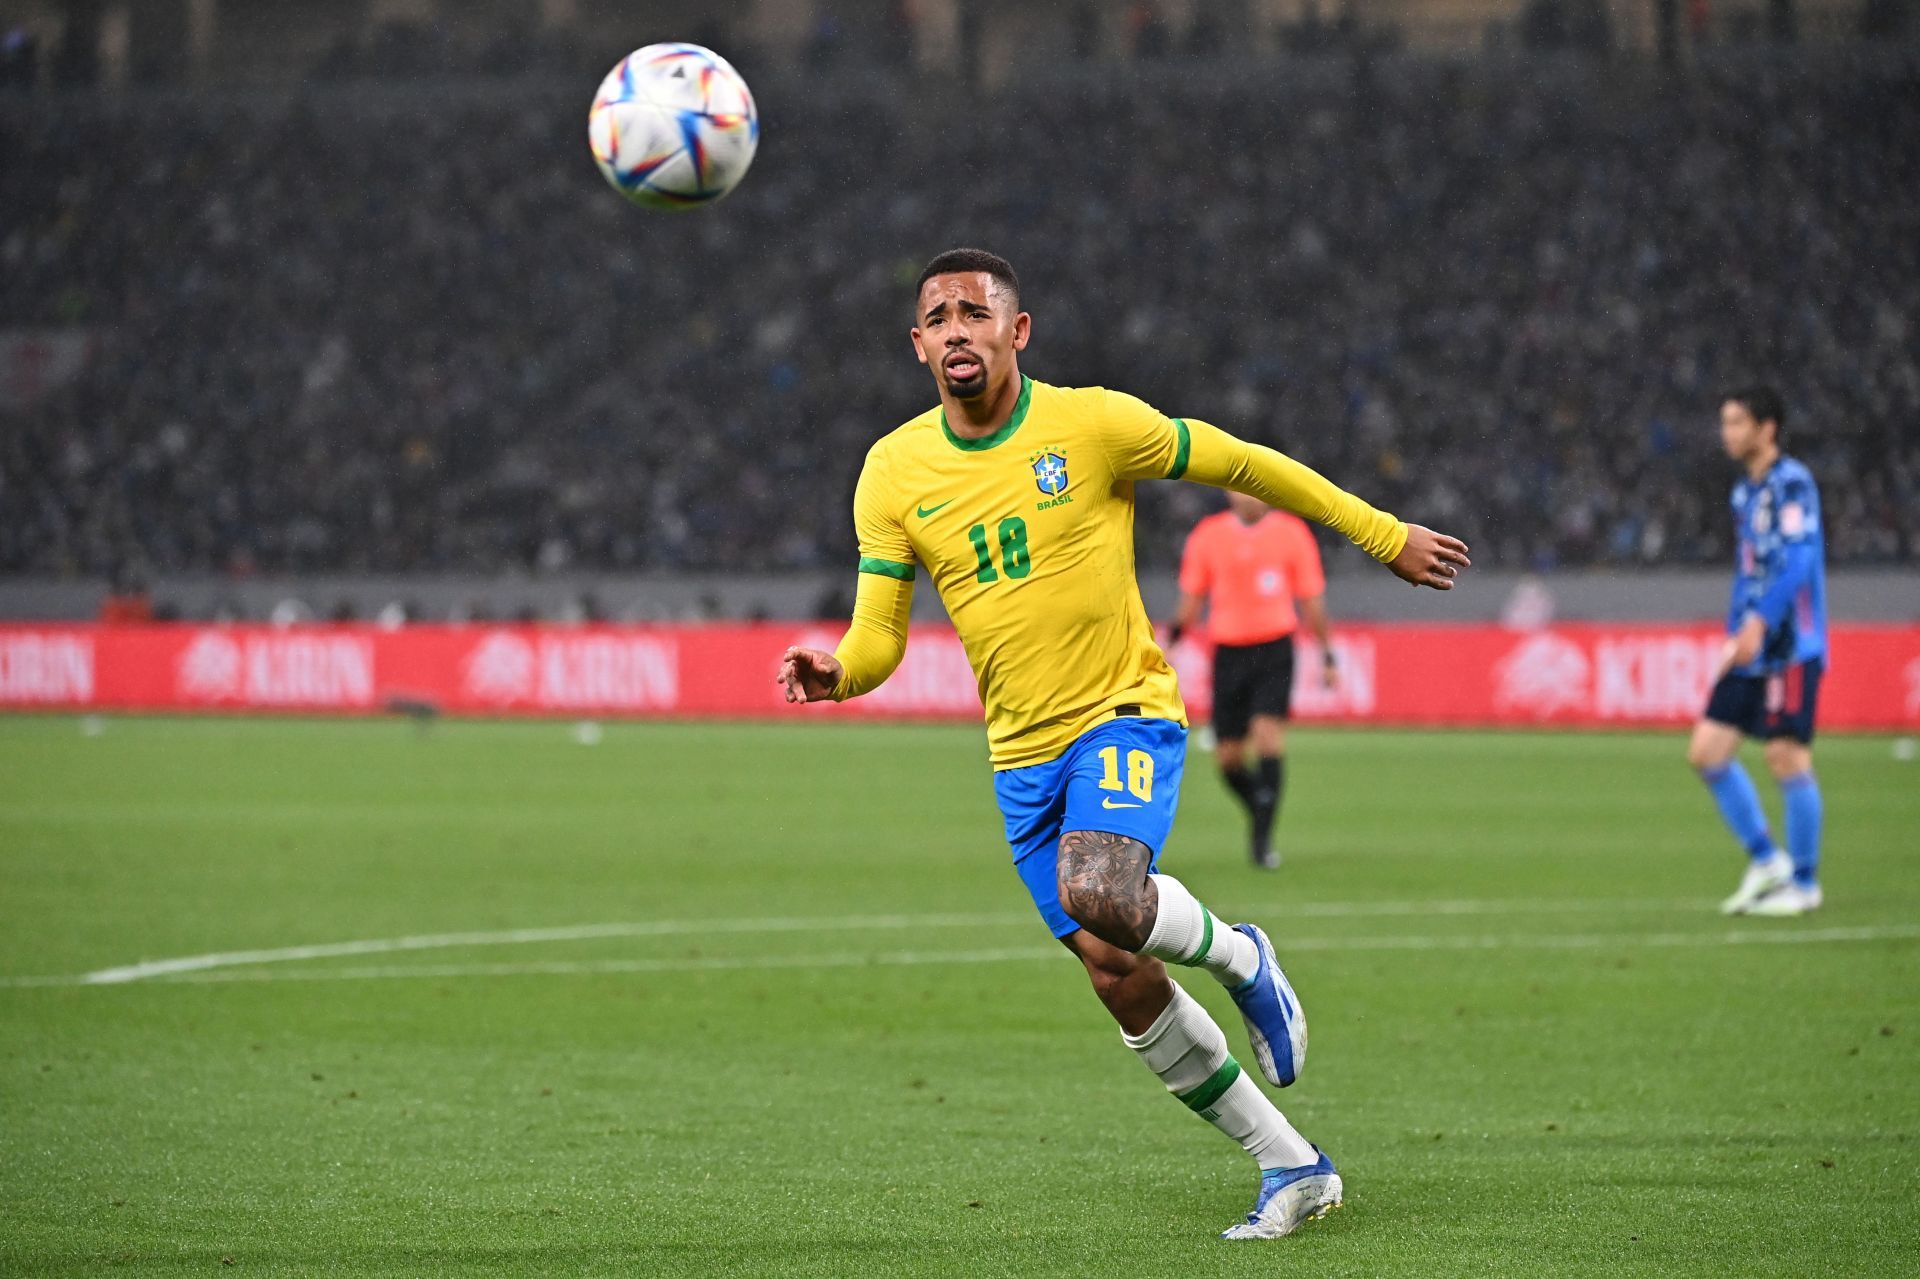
[854,378,1190,768]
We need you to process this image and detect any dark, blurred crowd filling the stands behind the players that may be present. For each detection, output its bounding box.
[0,58,1920,574]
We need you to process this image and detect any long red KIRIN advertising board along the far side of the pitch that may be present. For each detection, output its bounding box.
[0,624,1920,730]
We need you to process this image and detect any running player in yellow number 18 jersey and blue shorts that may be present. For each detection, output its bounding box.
[778,250,1467,1239]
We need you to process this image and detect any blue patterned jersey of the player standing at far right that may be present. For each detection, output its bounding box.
[1726,455,1826,676]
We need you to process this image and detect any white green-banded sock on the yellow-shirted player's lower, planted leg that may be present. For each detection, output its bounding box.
[1121,985,1319,1171]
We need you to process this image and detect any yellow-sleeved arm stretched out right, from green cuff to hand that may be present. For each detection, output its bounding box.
[1173,419,1473,591]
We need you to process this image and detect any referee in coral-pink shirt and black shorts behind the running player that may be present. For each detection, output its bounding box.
[1171,494,1340,868]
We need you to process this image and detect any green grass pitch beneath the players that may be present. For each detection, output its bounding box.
[0,716,1920,1279]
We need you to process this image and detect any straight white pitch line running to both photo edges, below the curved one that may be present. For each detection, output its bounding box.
[0,924,1920,987]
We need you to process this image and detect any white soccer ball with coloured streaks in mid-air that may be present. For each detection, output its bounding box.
[588,44,760,209]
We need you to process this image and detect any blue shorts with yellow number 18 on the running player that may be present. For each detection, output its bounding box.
[993,716,1187,937]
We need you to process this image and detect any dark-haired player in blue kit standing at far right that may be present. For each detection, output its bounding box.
[1688,386,1826,916]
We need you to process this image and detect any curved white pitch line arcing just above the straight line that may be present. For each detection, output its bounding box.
[60,899,1701,985]
